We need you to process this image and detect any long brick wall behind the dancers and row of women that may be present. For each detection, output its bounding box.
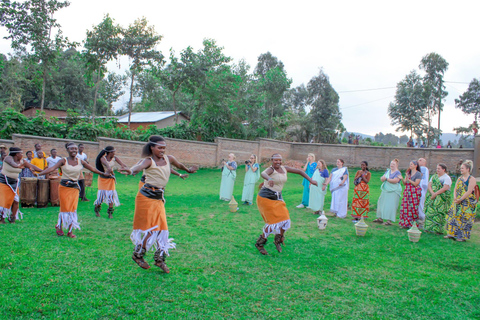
[4,134,480,171]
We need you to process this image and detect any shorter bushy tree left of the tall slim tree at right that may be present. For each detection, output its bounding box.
[388,70,426,136]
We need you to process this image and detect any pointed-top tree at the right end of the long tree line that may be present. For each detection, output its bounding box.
[307,70,345,143]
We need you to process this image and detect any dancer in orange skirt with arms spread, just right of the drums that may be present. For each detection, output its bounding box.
[39,142,108,238]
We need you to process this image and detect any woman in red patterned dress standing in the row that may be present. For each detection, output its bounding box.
[398,160,422,229]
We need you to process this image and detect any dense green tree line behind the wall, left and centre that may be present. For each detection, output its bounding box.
[0,0,345,143]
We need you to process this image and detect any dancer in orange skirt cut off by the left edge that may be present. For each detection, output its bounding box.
[0,147,41,224]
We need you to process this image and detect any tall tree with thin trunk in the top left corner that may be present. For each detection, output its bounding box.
[0,0,72,110]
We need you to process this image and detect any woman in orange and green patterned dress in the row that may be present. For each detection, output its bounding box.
[352,161,372,222]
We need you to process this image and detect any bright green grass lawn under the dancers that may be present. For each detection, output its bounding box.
[0,168,480,319]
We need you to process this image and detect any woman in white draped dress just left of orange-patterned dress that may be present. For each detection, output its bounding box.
[327,159,350,219]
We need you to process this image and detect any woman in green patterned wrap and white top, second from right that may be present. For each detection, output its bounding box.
[424,163,452,234]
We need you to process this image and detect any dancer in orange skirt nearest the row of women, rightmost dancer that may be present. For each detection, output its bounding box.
[255,153,317,255]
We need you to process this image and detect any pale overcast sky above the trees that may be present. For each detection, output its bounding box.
[0,0,480,135]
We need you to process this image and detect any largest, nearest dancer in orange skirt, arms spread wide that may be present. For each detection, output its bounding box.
[125,136,197,273]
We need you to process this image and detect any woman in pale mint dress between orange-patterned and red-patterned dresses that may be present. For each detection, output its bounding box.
[373,159,402,226]
